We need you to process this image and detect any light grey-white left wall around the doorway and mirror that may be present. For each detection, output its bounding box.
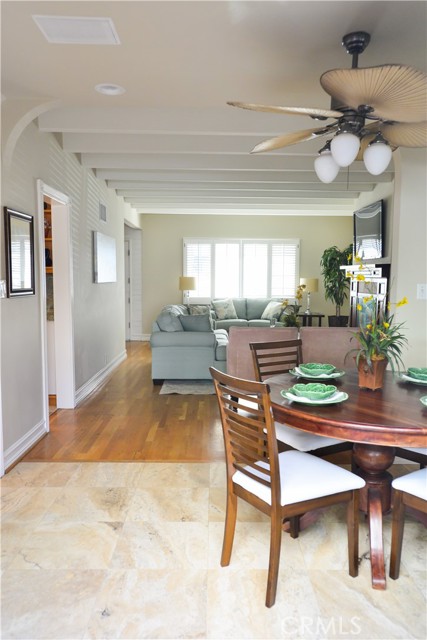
[0,123,140,460]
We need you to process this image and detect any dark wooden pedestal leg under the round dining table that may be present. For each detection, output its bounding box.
[353,443,395,589]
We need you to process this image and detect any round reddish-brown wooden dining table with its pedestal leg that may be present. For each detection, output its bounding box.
[268,370,427,589]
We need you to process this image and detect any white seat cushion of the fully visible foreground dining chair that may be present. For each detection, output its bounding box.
[233,451,365,506]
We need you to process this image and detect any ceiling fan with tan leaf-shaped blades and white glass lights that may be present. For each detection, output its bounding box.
[227,31,427,183]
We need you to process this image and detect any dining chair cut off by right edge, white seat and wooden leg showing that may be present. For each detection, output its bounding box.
[390,468,427,580]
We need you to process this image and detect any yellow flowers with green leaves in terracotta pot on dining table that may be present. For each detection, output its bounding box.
[347,257,408,371]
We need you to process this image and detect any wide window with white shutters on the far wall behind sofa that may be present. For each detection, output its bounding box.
[183,238,299,302]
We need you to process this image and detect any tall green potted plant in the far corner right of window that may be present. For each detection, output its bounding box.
[320,244,353,327]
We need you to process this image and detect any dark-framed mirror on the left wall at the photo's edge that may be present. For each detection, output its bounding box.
[4,207,35,298]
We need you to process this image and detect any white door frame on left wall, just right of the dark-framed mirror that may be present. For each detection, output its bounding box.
[37,180,76,425]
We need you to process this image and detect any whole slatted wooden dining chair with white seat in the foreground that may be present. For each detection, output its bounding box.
[209,367,365,607]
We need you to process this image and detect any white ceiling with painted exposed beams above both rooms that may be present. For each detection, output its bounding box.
[1,0,427,215]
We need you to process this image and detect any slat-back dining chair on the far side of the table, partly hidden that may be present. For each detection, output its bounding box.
[249,339,354,460]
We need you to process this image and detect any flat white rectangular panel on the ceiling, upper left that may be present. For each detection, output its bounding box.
[33,15,120,44]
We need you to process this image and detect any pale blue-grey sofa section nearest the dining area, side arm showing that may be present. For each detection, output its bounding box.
[150,304,228,384]
